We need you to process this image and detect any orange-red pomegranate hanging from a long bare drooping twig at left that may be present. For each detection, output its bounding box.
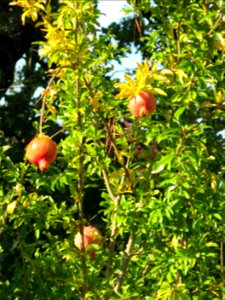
[26,135,57,171]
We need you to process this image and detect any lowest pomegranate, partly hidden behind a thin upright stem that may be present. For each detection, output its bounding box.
[74,225,102,260]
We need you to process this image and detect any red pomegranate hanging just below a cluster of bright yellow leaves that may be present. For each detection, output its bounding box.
[128,91,156,118]
